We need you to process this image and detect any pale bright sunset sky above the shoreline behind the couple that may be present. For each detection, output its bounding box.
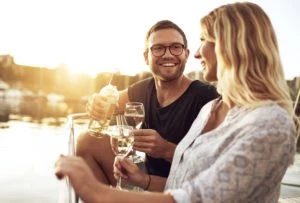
[0,0,300,79]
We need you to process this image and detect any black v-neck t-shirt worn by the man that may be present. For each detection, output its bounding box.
[128,78,218,177]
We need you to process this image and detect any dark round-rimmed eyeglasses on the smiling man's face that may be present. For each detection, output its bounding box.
[150,43,185,57]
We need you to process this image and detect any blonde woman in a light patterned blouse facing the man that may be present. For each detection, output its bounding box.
[56,2,296,202]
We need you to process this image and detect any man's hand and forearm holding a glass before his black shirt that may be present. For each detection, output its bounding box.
[133,129,176,161]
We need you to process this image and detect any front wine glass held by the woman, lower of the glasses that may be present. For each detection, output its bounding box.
[106,120,134,189]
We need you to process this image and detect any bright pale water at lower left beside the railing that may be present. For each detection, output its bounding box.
[0,121,68,203]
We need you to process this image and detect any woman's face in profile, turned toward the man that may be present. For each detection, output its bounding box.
[195,37,217,82]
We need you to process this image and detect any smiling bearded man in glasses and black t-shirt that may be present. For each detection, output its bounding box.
[77,20,217,189]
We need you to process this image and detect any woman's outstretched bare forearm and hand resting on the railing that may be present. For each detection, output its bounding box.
[55,156,174,203]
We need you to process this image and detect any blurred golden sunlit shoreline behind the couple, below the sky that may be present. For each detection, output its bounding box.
[0,55,300,129]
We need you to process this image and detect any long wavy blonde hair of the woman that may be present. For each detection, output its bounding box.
[201,2,294,115]
